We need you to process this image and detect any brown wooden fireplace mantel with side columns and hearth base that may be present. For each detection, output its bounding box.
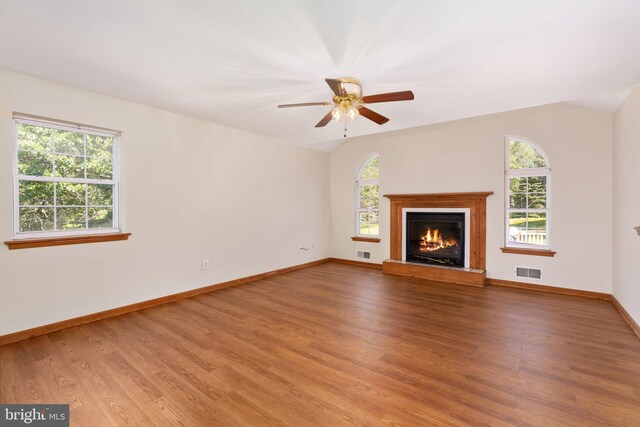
[383,191,493,286]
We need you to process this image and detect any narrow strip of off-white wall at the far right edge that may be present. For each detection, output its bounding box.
[613,86,640,324]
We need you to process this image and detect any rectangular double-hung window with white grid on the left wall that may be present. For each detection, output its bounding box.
[14,117,119,239]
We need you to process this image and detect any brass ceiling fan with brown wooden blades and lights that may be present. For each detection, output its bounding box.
[278,77,414,130]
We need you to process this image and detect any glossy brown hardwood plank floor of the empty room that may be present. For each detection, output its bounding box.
[0,263,640,426]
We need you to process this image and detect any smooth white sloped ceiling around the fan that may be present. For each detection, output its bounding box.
[0,0,640,149]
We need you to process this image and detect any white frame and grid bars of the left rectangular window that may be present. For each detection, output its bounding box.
[13,116,120,240]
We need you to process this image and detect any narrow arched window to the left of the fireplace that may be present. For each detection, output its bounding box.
[356,153,380,236]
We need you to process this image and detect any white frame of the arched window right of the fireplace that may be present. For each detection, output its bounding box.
[504,135,552,251]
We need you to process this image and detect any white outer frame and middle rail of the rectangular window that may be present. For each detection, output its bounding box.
[12,113,122,240]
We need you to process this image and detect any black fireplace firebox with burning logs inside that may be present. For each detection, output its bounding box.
[405,212,466,268]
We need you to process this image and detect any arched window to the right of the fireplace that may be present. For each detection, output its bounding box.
[505,136,551,249]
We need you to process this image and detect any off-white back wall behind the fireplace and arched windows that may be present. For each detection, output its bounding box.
[331,104,612,293]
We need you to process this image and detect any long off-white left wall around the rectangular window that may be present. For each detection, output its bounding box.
[0,70,330,335]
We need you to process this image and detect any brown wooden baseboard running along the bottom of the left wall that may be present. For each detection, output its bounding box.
[0,258,333,346]
